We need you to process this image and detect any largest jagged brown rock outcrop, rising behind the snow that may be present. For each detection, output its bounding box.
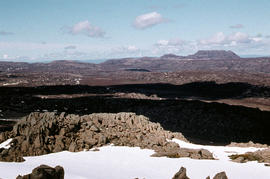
[0,112,213,162]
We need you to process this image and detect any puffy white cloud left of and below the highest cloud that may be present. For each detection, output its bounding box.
[64,20,105,37]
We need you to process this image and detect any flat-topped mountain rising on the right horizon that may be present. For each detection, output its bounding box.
[187,50,241,60]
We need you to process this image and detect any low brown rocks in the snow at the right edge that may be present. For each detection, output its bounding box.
[230,148,270,166]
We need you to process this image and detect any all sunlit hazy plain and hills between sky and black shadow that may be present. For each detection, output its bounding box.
[0,51,270,86]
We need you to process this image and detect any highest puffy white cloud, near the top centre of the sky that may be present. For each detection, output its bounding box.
[133,12,166,29]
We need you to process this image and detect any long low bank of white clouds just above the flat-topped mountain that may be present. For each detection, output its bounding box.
[151,32,270,56]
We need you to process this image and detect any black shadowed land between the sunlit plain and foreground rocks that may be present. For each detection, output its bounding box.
[0,82,270,144]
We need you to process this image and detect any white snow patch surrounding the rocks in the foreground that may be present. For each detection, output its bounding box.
[0,139,270,179]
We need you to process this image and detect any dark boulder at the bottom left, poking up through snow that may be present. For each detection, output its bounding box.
[16,165,65,179]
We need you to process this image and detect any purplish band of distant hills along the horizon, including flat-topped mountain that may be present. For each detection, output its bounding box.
[0,50,270,75]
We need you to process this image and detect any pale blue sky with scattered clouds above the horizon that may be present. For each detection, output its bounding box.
[0,0,270,61]
